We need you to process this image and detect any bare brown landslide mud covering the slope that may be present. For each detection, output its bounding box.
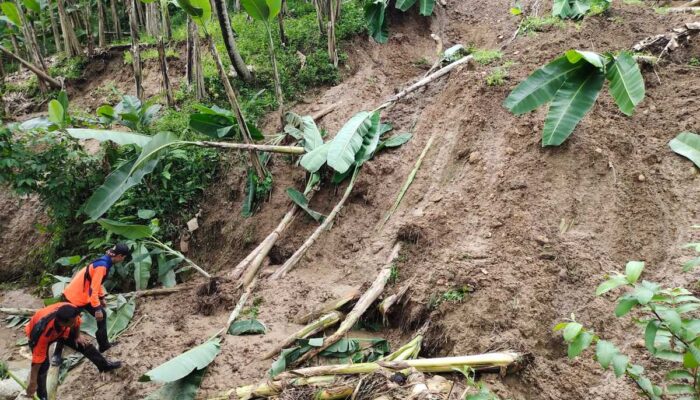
[0,0,700,400]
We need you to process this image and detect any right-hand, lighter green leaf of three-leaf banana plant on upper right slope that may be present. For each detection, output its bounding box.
[607,51,644,115]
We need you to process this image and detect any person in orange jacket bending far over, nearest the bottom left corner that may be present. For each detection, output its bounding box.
[25,302,122,400]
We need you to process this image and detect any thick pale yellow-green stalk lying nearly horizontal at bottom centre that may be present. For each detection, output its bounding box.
[277,352,522,380]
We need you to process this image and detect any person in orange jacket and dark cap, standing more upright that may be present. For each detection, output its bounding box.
[51,243,131,365]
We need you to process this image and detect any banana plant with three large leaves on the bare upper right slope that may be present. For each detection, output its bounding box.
[503,50,645,146]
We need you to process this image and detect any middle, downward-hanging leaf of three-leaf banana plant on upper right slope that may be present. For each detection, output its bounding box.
[542,63,605,146]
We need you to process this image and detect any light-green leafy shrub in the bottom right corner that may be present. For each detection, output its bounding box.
[554,236,700,400]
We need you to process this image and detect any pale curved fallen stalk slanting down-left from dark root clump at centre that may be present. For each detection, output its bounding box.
[294,243,401,365]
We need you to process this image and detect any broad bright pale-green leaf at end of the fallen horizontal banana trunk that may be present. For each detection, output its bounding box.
[327,111,372,174]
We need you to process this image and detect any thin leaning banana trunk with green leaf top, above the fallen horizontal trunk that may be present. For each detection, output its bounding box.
[176,0,267,181]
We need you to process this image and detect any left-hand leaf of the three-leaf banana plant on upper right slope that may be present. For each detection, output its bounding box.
[503,56,587,115]
